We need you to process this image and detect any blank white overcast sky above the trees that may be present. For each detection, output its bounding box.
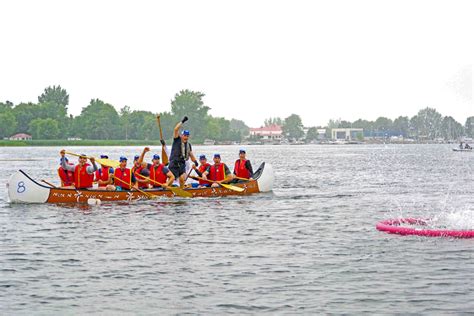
[0,0,474,127]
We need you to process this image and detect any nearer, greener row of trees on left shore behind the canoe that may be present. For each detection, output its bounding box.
[0,86,249,142]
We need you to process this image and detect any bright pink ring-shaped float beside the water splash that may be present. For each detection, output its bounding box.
[375,218,474,238]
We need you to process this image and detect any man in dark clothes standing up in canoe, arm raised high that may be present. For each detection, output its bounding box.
[169,116,199,188]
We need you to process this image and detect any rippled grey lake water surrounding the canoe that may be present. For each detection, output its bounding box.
[0,145,474,314]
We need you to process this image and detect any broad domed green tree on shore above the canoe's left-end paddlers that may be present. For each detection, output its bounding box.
[74,99,121,139]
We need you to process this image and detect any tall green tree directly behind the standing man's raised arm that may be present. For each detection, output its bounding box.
[171,89,210,140]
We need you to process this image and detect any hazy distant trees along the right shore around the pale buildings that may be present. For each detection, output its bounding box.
[265,107,474,141]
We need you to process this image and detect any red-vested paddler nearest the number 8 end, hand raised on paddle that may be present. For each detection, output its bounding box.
[59,149,97,189]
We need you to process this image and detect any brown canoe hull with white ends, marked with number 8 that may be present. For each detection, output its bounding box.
[7,162,274,203]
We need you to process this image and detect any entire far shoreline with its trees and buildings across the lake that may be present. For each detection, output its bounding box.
[0,86,474,147]
